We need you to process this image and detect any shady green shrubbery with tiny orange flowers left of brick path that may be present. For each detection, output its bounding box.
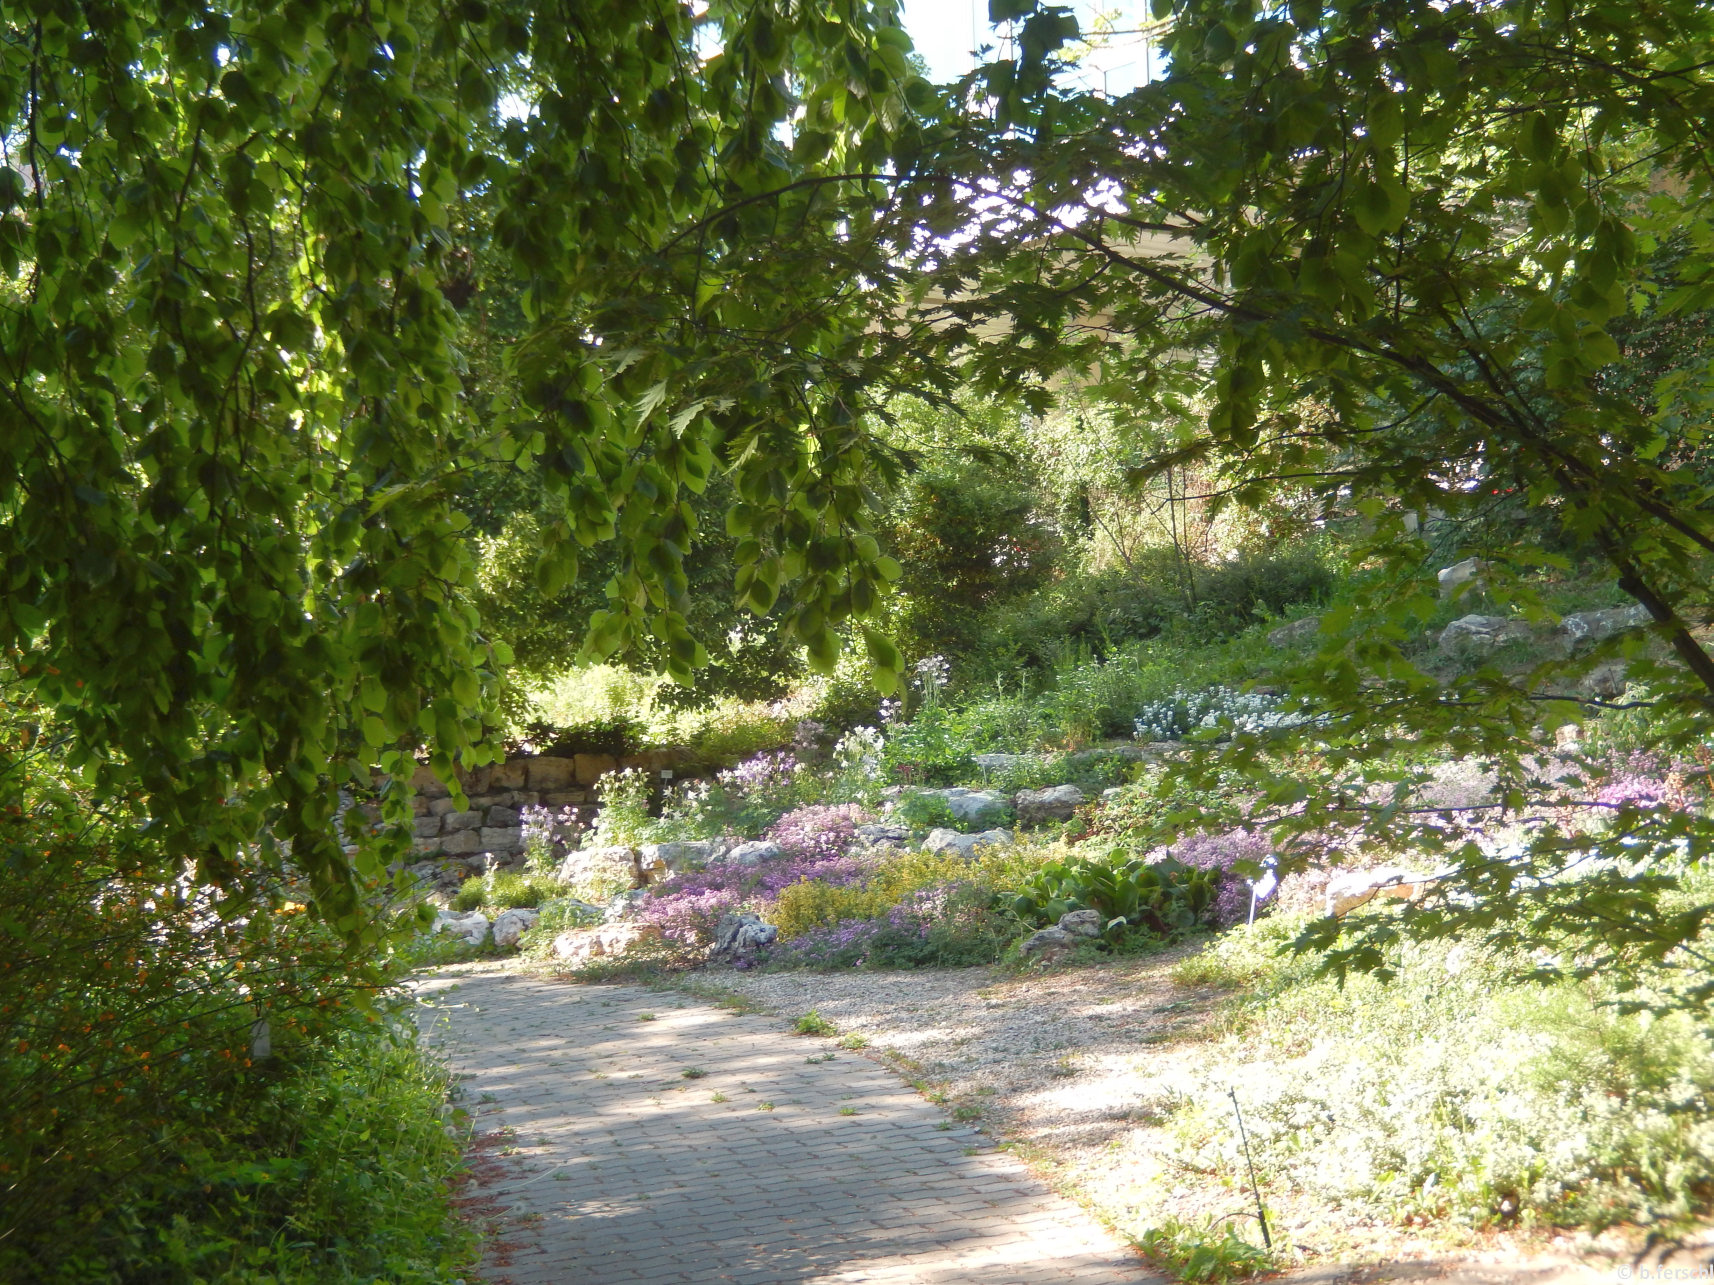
[0,814,468,1285]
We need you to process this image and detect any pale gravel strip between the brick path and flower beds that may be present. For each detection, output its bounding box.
[694,947,1707,1285]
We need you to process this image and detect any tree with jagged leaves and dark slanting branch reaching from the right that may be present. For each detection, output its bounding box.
[900,0,1714,1007]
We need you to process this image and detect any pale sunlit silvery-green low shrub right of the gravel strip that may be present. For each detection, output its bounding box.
[1172,922,1714,1228]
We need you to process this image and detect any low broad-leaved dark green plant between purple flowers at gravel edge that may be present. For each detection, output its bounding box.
[1011,846,1219,937]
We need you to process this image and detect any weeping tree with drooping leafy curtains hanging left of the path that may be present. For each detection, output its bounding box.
[0,0,932,930]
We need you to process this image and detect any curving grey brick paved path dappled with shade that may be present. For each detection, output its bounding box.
[418,973,1154,1285]
